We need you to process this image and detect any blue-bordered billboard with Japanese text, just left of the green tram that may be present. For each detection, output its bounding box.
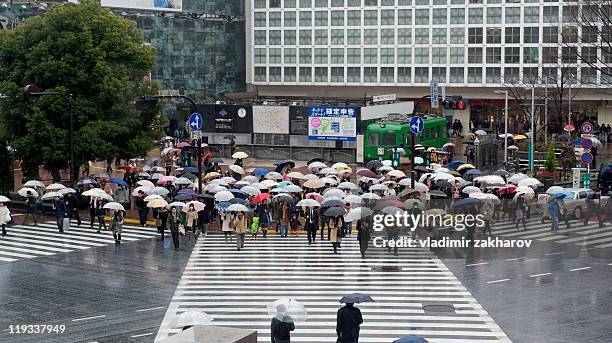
[308,106,357,141]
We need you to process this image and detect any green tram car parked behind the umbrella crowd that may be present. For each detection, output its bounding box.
[363,114,448,162]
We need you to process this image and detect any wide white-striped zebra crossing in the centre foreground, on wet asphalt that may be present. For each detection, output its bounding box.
[155,233,510,343]
